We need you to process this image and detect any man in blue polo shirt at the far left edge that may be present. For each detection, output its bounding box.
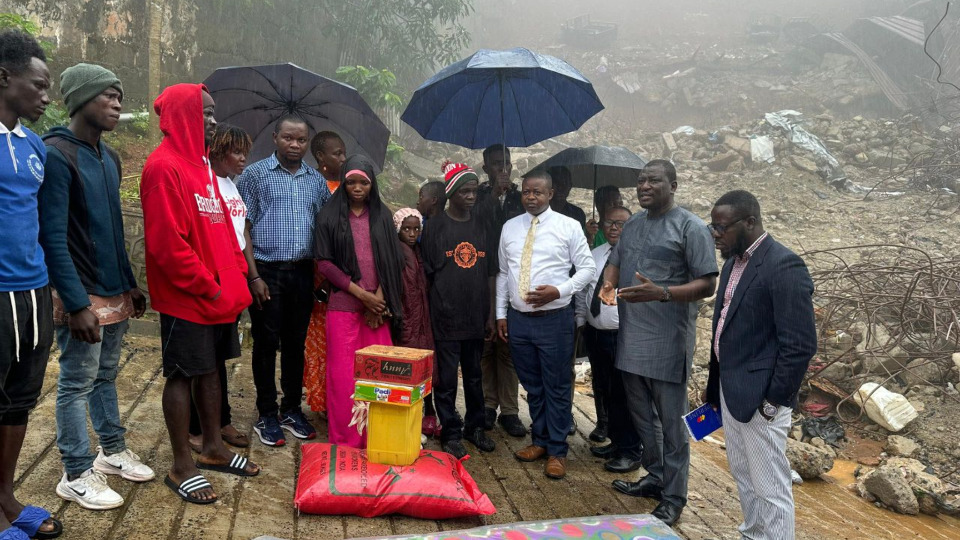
[0,30,63,538]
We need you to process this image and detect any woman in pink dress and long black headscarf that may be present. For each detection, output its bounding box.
[315,155,404,448]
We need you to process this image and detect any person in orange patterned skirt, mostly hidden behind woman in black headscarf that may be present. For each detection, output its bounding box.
[303,131,346,412]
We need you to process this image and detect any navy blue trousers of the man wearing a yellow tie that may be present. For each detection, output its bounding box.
[507,306,576,457]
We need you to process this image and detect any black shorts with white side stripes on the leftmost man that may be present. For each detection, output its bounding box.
[0,285,53,426]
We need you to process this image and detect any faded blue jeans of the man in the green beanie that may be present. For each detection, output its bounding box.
[57,321,127,478]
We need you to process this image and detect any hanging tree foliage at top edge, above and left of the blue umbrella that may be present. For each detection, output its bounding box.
[324,0,473,86]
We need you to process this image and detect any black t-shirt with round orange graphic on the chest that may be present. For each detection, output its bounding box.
[420,212,499,341]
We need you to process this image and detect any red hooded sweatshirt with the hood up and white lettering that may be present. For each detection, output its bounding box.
[140,84,251,324]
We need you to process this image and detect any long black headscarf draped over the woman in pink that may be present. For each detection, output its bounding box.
[314,154,404,336]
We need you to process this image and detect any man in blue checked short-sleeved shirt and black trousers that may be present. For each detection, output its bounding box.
[237,116,330,446]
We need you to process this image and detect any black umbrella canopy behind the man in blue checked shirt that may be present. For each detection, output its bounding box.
[203,63,390,168]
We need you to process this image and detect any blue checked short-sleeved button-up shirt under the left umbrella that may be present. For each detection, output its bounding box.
[237,154,330,262]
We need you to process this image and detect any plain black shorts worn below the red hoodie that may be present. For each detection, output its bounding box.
[160,313,240,377]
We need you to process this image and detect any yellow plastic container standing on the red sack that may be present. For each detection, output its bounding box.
[367,400,423,466]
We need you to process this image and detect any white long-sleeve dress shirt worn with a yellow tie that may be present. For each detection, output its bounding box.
[497,207,597,319]
